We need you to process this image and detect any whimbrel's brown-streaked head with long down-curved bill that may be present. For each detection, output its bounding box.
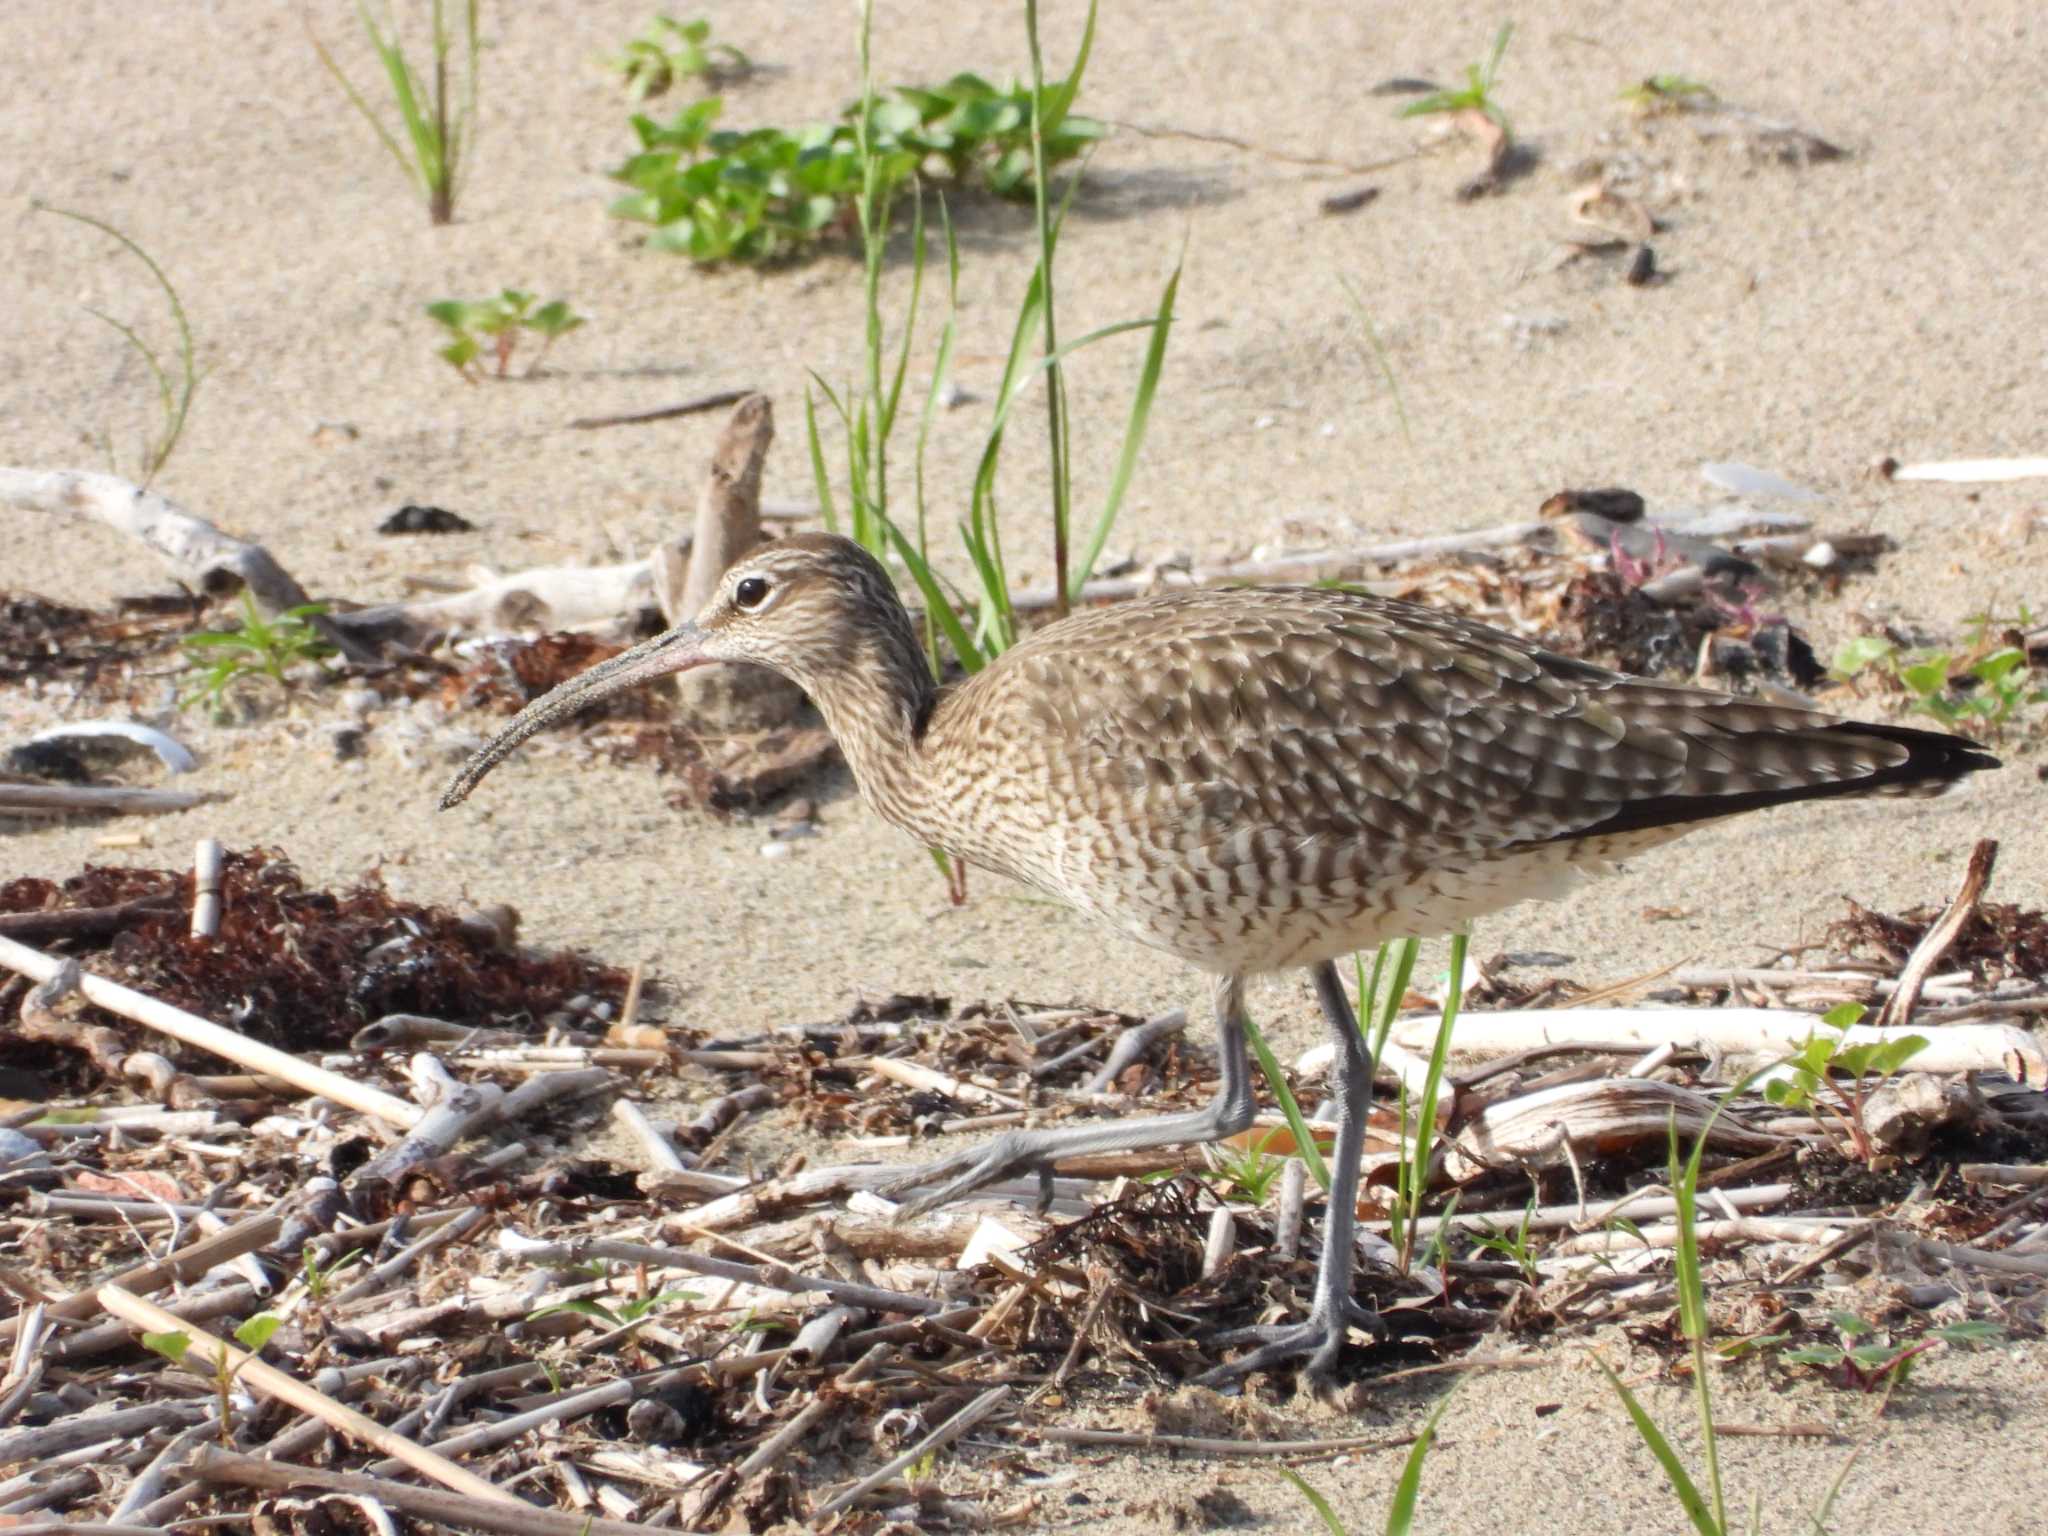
[440,532,930,811]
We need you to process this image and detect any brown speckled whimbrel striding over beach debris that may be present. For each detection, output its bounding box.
[442,535,1997,1380]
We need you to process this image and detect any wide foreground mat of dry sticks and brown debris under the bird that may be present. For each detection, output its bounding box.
[0,854,2048,1536]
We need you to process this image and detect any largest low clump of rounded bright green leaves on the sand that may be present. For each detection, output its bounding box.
[610,70,1108,264]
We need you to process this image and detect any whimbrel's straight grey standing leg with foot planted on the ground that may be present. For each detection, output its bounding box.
[1196,961,1386,1386]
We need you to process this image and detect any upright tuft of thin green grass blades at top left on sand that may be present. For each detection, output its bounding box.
[305,0,481,223]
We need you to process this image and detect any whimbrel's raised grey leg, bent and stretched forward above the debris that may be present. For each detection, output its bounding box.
[879,977,1251,1217]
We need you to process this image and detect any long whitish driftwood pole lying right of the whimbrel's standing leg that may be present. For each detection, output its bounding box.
[1393,1008,2048,1087]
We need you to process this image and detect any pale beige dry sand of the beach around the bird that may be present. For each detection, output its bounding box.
[0,0,2048,1536]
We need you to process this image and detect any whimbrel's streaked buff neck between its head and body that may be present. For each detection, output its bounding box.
[803,616,938,836]
